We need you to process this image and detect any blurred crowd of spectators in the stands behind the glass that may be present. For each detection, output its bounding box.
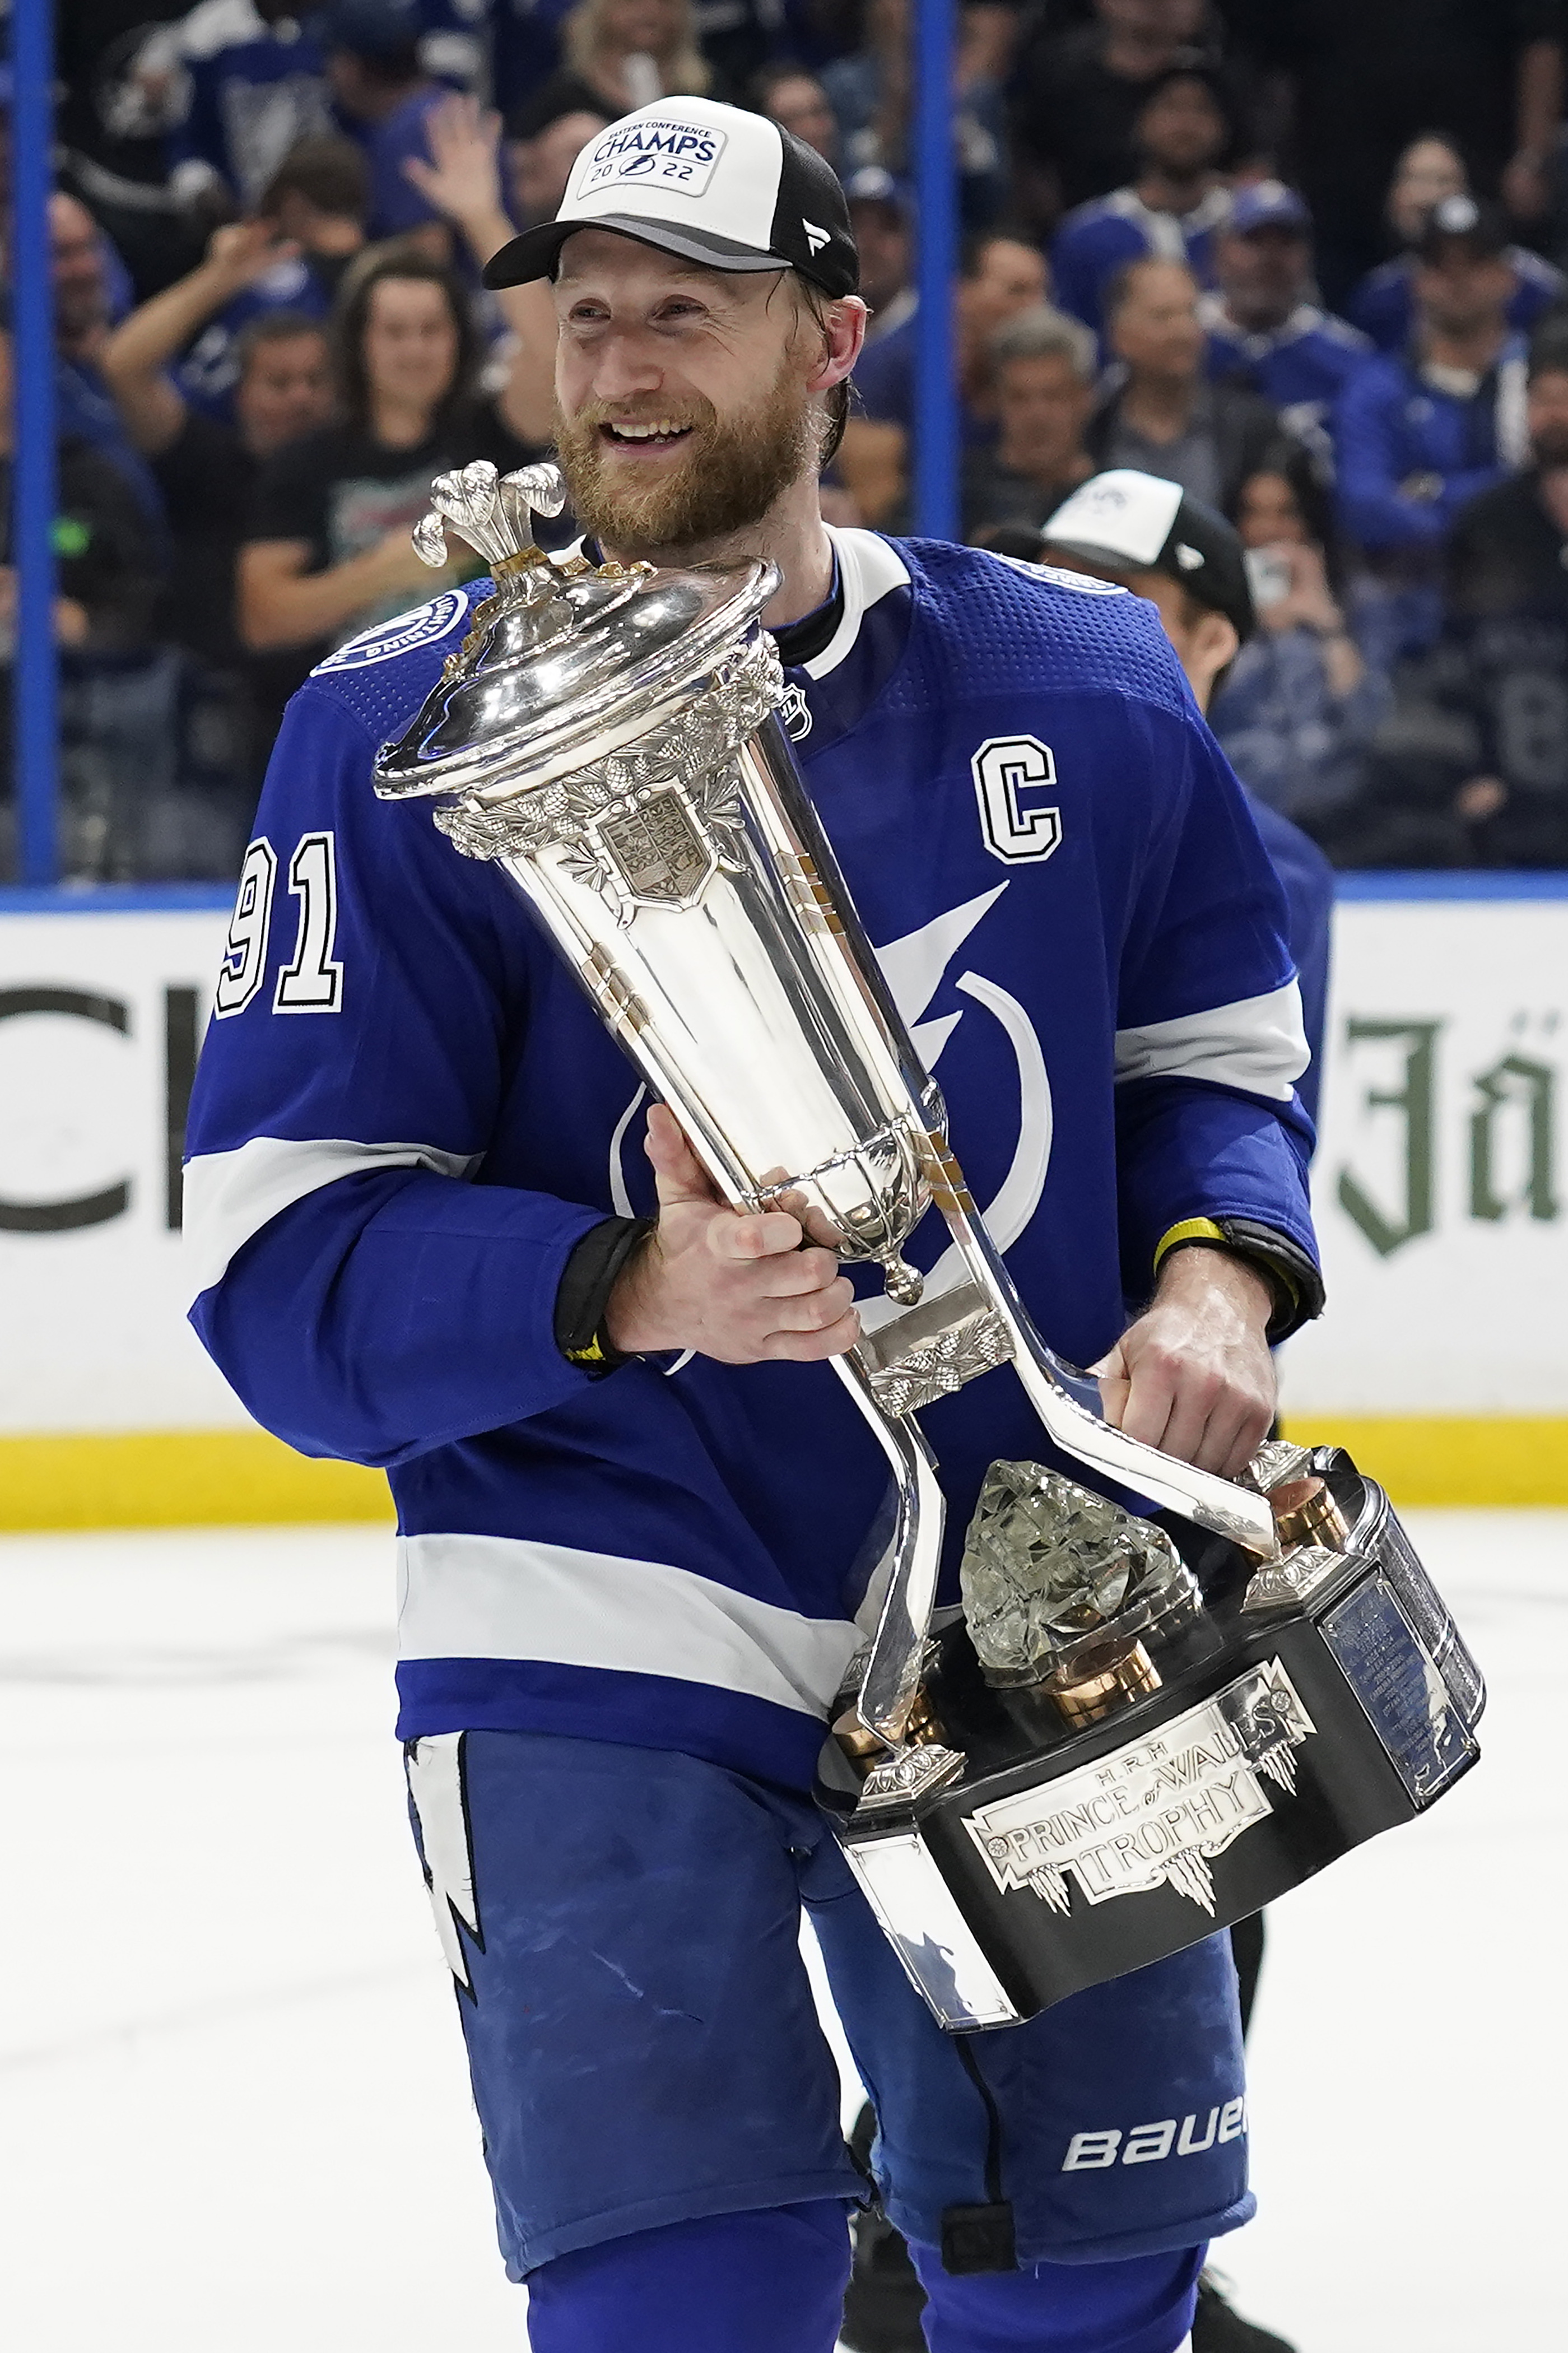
[0,0,1568,880]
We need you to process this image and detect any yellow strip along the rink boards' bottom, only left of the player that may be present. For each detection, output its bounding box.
[0,1431,393,1529]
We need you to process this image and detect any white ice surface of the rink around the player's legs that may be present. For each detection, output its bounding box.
[0,1513,1568,2353]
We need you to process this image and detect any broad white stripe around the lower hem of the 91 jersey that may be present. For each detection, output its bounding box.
[398,1534,862,1715]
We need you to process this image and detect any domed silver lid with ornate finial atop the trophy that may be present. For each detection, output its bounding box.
[374,459,779,807]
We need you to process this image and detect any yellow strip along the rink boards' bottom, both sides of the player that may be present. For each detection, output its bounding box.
[0,1414,1568,1532]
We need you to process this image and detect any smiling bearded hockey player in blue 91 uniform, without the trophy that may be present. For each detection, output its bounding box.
[186,99,1321,2353]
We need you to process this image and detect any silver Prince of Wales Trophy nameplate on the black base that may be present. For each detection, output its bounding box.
[963,1659,1316,1913]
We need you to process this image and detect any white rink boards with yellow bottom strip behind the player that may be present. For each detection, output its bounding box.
[0,875,1568,1527]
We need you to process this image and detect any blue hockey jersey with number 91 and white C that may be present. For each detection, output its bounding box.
[186,532,1311,1786]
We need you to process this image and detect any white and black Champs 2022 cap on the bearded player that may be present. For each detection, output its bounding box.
[485,99,859,296]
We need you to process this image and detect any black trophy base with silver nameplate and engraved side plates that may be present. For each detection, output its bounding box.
[817,1447,1486,2033]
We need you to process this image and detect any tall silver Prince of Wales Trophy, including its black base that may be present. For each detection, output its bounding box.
[374,463,1483,2031]
